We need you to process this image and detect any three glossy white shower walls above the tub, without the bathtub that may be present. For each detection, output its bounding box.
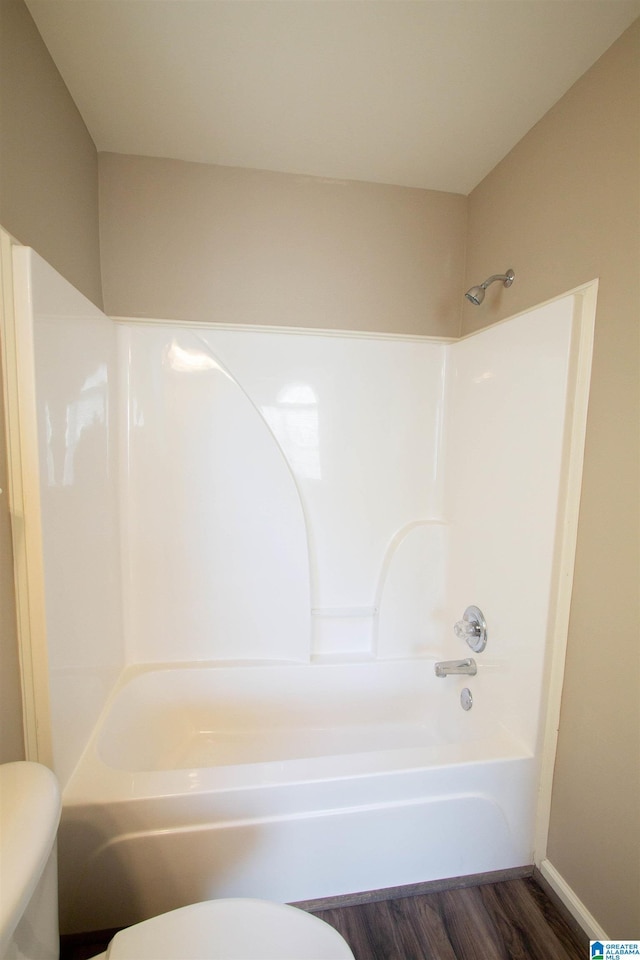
[6,247,588,925]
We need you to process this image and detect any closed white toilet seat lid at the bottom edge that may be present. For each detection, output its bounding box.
[105,899,354,960]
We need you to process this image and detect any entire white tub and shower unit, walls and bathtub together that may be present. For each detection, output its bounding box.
[8,247,592,932]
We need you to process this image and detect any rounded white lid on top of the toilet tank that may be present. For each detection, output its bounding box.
[0,760,61,956]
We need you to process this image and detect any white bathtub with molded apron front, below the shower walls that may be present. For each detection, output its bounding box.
[59,659,535,933]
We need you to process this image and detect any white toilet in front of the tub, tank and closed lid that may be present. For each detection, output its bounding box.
[0,761,354,960]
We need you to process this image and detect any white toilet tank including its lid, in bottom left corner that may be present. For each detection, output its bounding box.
[0,761,60,960]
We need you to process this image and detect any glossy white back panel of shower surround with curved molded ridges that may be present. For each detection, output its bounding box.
[119,324,446,661]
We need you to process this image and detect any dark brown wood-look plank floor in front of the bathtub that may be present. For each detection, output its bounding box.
[60,877,589,960]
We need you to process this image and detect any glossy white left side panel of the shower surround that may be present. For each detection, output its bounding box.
[20,247,125,782]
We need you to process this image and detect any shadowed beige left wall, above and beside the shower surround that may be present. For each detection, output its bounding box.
[0,0,102,762]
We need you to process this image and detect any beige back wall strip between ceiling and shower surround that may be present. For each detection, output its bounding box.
[100,154,466,336]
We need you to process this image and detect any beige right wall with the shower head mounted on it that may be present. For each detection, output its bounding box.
[463,21,640,938]
